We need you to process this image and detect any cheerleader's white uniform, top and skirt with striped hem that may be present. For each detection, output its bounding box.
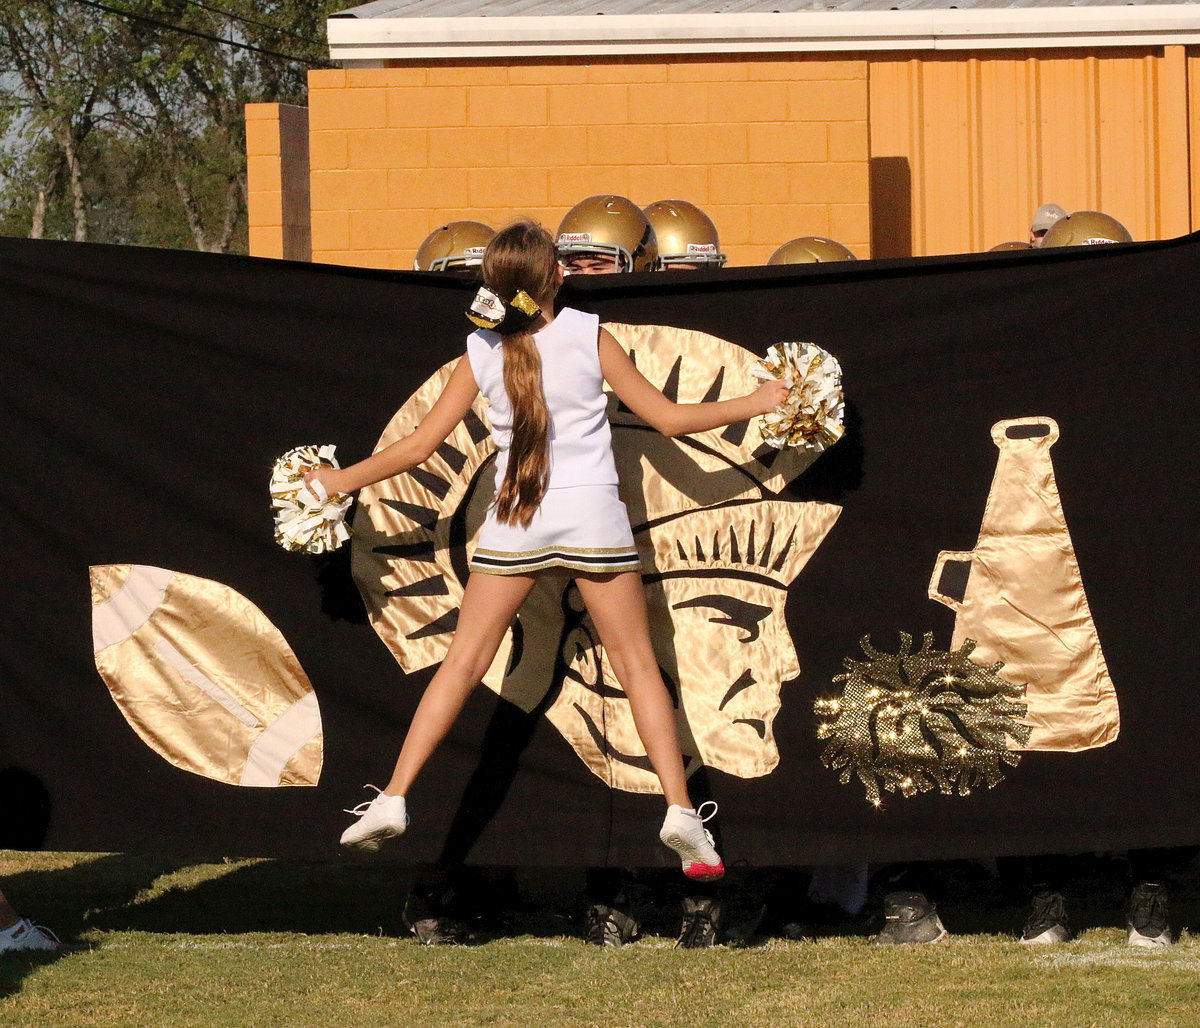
[467,307,641,575]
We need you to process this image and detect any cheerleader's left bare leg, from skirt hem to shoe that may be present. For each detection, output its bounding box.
[384,573,534,796]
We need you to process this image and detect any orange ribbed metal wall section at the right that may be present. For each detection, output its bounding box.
[870,47,1196,256]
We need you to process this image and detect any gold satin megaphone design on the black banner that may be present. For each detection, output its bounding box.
[929,417,1121,751]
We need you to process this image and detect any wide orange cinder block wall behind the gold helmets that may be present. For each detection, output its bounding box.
[308,55,870,269]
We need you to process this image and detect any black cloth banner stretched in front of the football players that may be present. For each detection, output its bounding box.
[0,230,1200,866]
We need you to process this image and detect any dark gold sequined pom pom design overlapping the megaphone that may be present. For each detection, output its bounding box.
[814,632,1031,806]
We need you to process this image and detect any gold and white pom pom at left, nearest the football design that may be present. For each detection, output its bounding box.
[271,445,350,553]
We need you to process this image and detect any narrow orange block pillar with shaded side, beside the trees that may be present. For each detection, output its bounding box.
[246,103,312,260]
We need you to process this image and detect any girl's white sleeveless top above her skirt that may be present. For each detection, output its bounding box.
[467,307,617,489]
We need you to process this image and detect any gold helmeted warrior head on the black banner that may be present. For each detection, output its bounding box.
[352,325,841,793]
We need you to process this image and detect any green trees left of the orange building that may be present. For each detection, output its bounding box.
[0,0,344,252]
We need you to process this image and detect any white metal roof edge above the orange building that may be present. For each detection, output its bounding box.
[325,4,1200,62]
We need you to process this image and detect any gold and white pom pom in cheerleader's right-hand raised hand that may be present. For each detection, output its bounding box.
[750,343,846,453]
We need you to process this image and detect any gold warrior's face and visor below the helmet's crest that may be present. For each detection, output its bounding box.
[556,500,840,793]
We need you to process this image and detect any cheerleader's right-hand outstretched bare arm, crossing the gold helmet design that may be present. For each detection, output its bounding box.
[599,329,787,437]
